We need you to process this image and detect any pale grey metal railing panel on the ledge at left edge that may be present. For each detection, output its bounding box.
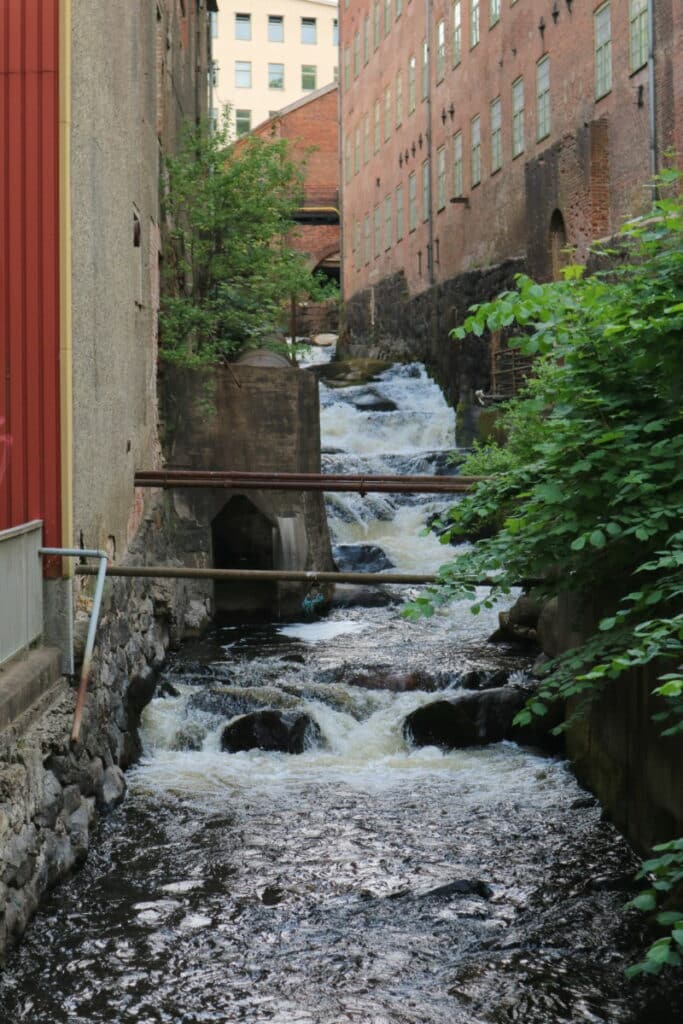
[0,519,43,666]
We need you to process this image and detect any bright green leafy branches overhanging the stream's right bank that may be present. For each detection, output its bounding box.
[407,171,683,971]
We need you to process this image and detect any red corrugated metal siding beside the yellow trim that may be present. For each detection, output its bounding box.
[0,0,61,569]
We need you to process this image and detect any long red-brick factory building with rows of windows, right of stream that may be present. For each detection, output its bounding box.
[340,0,683,344]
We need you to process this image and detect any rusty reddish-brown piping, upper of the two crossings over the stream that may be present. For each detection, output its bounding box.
[135,469,485,495]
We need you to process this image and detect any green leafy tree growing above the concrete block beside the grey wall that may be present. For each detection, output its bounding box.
[160,122,339,366]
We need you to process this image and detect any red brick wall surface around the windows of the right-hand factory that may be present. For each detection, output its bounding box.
[340,0,683,298]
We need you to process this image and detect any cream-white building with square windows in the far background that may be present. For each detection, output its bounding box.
[212,0,339,135]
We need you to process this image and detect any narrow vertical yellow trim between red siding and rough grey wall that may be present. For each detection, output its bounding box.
[59,0,74,577]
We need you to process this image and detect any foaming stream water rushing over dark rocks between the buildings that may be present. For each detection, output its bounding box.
[0,356,683,1024]
